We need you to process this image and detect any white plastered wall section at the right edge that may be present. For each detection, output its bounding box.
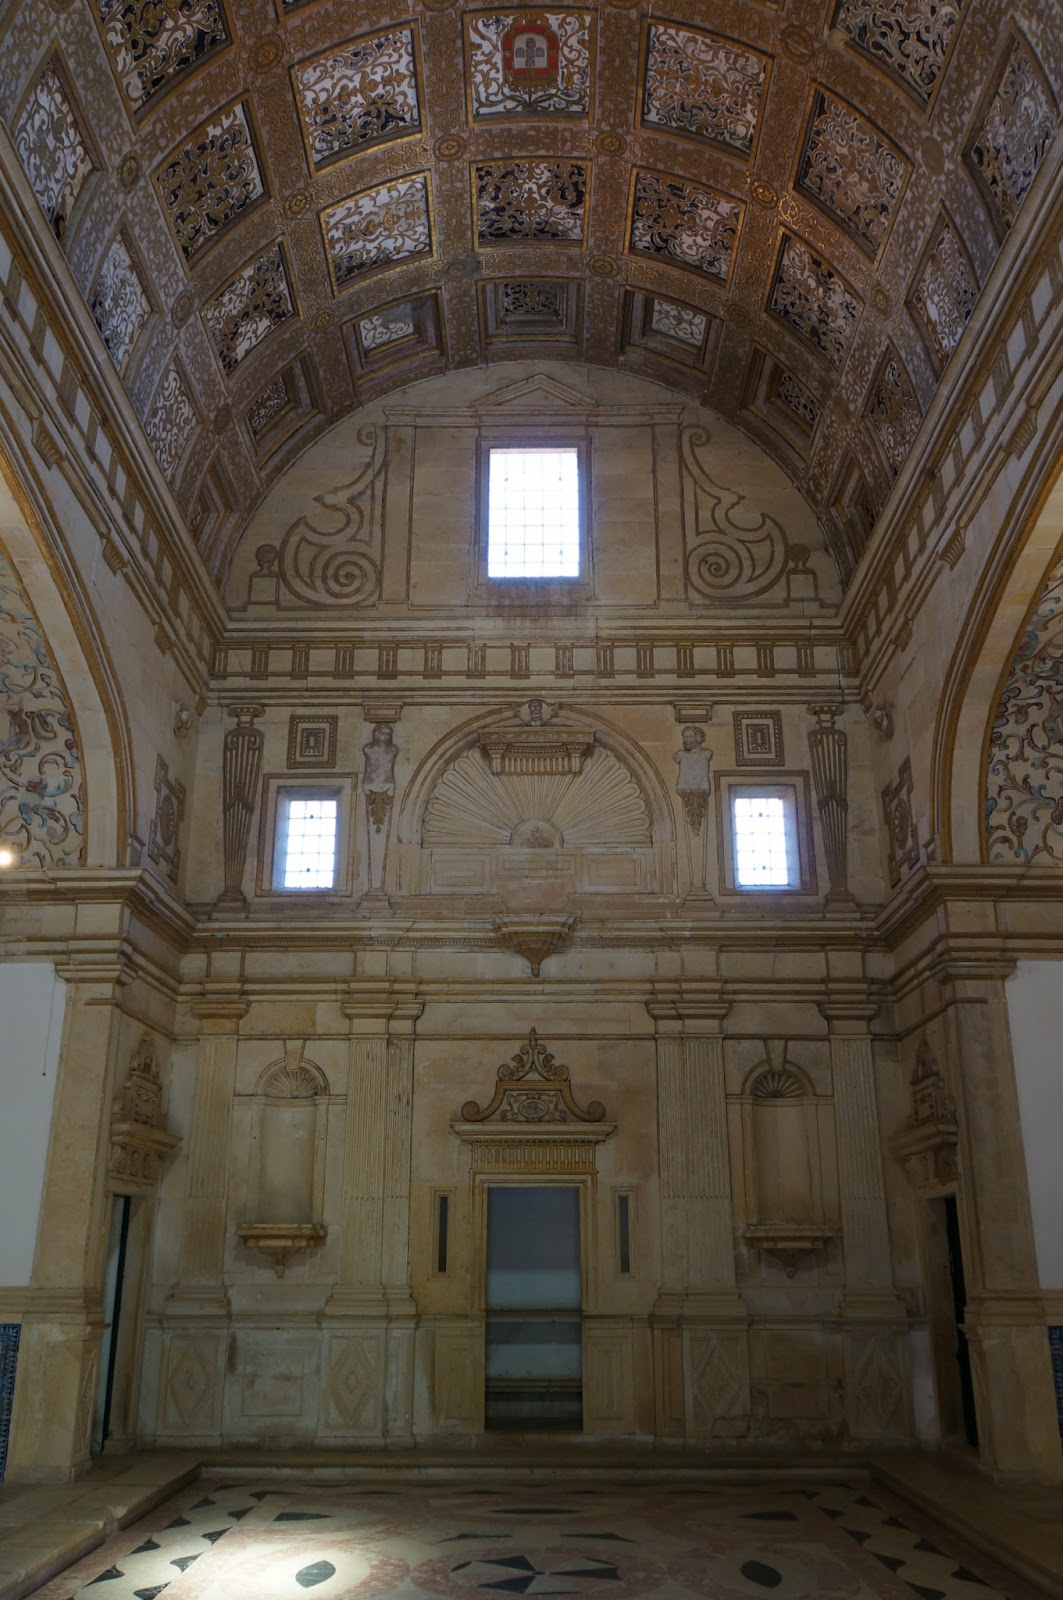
[1007,962,1063,1290]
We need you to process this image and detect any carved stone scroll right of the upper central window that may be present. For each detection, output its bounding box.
[682,427,789,602]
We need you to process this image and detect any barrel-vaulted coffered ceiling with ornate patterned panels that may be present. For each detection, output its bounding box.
[0,0,1063,588]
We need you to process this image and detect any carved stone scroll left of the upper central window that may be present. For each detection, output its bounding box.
[279,427,384,606]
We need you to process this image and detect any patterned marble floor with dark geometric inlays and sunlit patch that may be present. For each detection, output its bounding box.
[35,1478,1037,1600]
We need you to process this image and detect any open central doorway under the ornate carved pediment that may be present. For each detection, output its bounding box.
[483,1184,583,1430]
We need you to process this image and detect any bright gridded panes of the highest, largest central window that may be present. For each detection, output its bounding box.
[487,446,580,578]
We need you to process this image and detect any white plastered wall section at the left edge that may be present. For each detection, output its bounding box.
[0,962,66,1288]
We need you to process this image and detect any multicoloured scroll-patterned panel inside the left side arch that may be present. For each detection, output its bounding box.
[0,550,85,867]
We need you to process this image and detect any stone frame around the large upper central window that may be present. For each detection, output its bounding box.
[475,422,594,606]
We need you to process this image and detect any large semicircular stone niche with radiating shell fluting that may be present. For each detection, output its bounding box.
[399,702,676,909]
